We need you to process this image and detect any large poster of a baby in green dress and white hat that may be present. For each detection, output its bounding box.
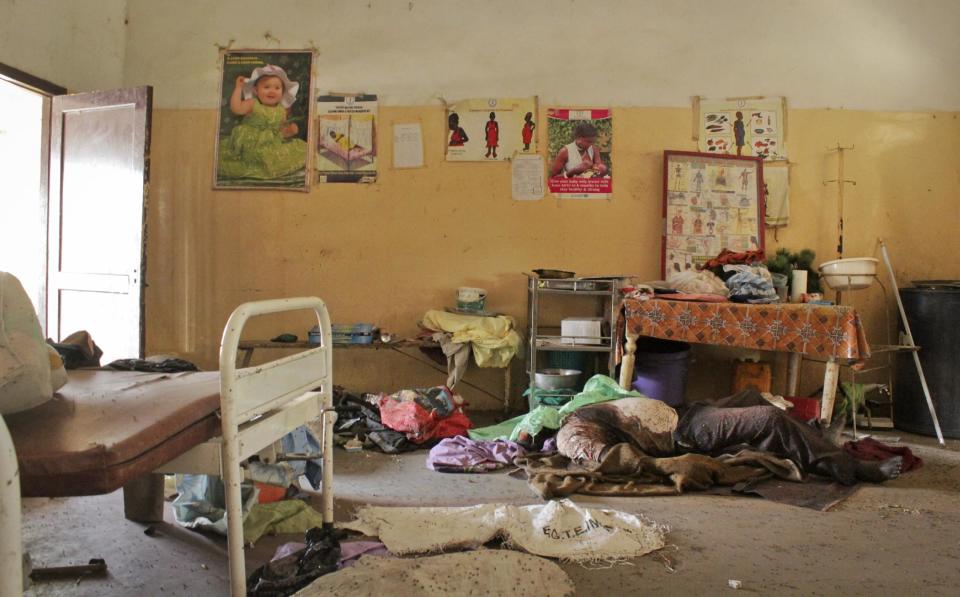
[214,50,313,191]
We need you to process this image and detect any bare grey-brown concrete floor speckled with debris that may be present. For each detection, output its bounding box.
[24,433,960,596]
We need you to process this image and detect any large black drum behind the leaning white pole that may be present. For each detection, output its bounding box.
[893,280,960,438]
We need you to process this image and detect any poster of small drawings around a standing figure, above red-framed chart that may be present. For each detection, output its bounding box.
[694,97,787,161]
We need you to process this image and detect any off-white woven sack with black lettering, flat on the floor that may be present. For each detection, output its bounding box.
[341,500,668,561]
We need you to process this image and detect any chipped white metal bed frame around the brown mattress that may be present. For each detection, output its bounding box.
[0,297,336,596]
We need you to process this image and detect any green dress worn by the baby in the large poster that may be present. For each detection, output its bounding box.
[217,100,307,180]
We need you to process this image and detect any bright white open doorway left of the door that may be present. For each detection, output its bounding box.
[0,78,49,318]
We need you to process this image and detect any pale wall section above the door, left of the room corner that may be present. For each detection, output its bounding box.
[0,0,127,91]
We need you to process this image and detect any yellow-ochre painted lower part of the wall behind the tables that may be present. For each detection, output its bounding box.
[146,106,960,408]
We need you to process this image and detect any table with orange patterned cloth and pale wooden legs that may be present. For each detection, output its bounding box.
[618,299,870,422]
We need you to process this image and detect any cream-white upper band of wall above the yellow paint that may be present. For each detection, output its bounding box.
[0,0,960,111]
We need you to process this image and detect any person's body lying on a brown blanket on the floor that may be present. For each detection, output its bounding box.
[515,378,900,498]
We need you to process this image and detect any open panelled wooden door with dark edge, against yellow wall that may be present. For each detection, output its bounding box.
[47,87,153,364]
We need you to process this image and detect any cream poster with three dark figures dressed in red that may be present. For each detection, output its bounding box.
[445,97,539,162]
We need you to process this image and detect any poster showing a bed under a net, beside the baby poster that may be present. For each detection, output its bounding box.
[314,95,377,182]
